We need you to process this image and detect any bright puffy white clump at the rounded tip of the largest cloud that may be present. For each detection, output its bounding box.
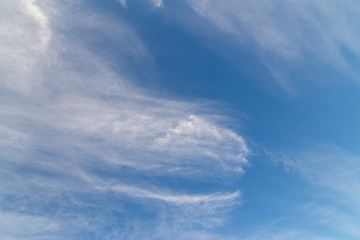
[153,115,249,172]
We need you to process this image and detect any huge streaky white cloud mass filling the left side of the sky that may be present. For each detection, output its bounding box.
[0,0,250,239]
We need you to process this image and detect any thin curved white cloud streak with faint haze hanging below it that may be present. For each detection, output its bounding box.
[110,185,240,229]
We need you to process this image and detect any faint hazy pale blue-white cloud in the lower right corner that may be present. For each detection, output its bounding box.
[281,143,360,239]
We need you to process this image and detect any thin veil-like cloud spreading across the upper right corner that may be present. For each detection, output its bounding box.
[180,0,360,95]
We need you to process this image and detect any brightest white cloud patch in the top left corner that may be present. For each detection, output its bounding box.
[0,0,51,92]
